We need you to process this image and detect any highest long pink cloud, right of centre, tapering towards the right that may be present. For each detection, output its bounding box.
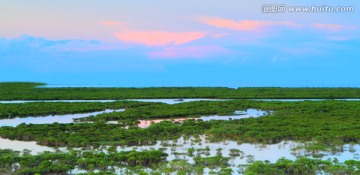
[200,17,299,31]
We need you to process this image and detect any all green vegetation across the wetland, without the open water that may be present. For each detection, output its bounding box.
[0,83,360,175]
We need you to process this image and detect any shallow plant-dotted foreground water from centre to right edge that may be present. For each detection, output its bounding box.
[110,136,360,174]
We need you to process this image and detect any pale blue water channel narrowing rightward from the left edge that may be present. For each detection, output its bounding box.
[0,109,124,127]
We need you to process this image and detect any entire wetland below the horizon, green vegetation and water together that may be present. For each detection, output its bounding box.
[0,83,360,174]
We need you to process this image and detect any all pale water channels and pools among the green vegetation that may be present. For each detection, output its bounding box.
[0,99,360,174]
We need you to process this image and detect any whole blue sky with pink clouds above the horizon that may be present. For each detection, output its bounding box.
[0,0,360,87]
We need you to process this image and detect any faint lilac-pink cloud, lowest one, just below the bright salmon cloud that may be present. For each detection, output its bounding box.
[149,46,228,59]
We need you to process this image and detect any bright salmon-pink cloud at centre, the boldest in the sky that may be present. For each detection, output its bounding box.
[115,31,206,46]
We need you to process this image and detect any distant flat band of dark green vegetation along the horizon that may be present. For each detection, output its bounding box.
[0,83,360,100]
